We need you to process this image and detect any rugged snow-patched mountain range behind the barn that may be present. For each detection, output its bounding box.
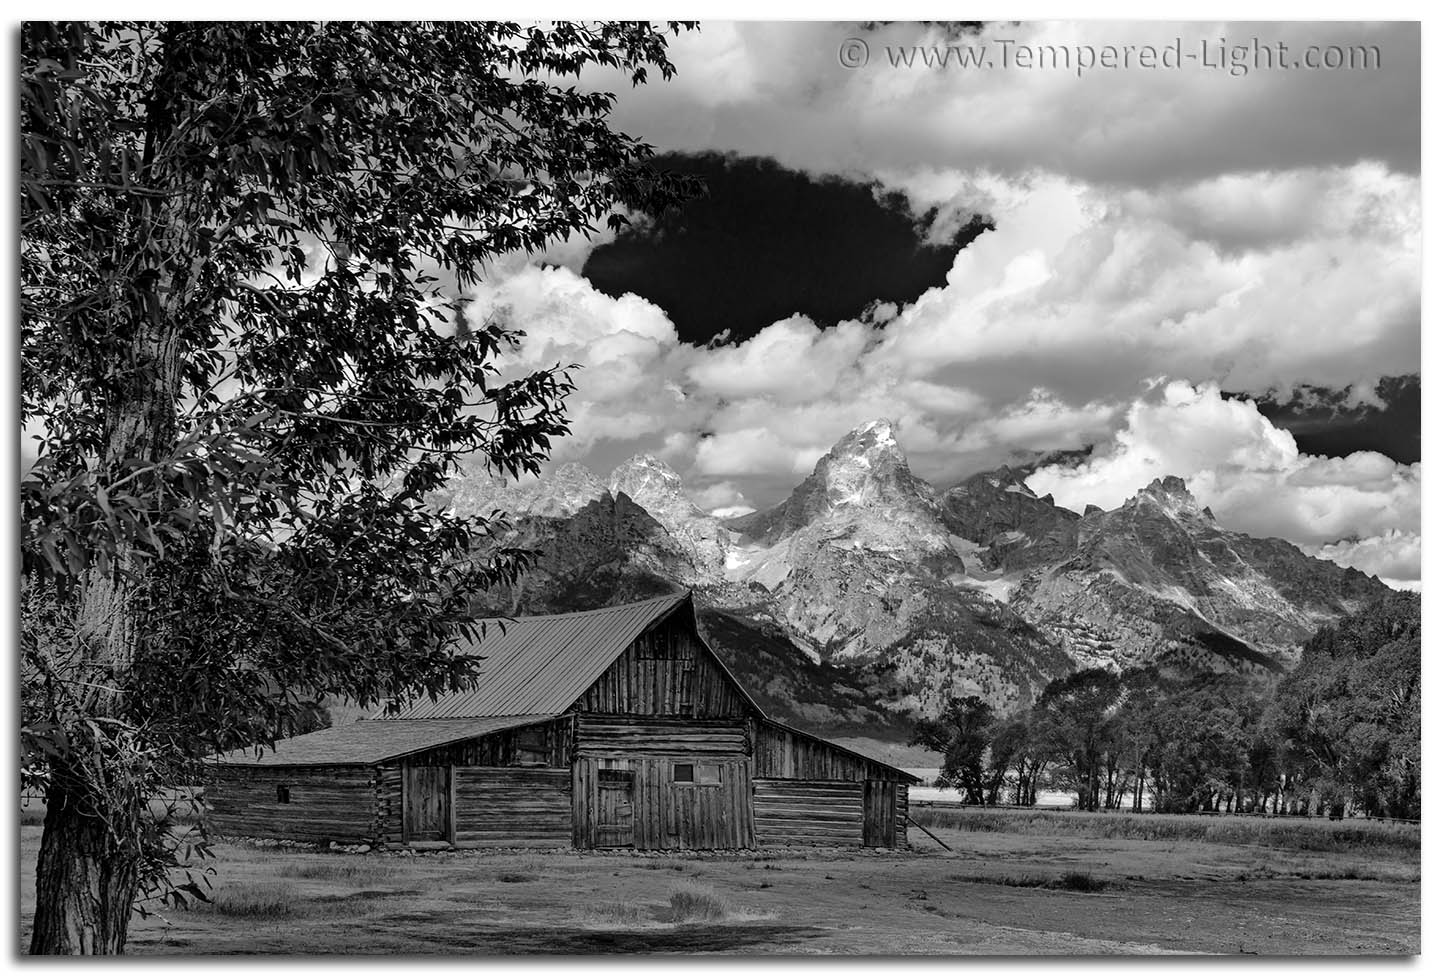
[433,421,1390,732]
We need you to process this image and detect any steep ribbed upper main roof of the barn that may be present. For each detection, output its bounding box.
[373,593,760,721]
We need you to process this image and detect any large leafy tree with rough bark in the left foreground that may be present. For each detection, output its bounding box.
[20,23,694,953]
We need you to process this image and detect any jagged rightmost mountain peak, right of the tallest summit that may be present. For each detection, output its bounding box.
[1012,477,1387,672]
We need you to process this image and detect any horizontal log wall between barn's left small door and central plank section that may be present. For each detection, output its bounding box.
[451,767,571,848]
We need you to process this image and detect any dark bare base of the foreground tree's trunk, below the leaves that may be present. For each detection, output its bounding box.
[30,787,140,956]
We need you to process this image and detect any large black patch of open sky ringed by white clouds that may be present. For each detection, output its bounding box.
[584,153,983,345]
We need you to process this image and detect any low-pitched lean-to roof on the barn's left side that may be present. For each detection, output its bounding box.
[216,715,555,766]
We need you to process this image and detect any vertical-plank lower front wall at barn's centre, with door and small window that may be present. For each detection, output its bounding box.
[572,753,756,851]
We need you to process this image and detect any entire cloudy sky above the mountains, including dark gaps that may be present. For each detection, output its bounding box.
[467,22,1422,587]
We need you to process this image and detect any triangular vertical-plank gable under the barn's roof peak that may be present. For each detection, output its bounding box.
[575,614,750,718]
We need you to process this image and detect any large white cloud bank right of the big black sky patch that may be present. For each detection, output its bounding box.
[877,164,1420,405]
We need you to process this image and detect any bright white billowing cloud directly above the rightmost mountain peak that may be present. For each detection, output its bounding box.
[1027,381,1422,580]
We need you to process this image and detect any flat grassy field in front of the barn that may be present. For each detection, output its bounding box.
[20,810,1420,954]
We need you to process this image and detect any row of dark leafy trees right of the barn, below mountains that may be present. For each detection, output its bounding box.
[913,594,1422,819]
